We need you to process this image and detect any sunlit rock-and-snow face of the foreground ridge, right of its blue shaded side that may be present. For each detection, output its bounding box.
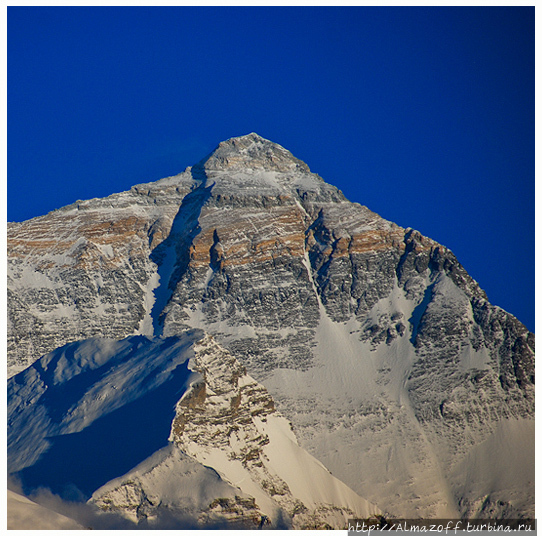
[171,336,378,529]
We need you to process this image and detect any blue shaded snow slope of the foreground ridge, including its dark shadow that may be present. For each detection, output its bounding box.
[8,332,200,486]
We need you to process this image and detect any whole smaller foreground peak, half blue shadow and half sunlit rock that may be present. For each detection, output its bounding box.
[8,330,379,528]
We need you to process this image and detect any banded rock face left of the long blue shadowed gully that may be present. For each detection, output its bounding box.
[8,174,191,373]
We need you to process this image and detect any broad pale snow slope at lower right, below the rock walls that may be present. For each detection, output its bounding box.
[264,277,535,518]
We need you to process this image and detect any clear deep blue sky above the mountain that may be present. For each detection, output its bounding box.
[7,7,535,330]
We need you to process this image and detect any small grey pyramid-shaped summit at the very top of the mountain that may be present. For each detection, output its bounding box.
[200,132,310,172]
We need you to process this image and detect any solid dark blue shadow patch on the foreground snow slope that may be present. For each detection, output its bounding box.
[17,361,191,500]
